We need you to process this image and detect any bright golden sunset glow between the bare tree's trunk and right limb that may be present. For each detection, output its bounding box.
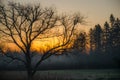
[31,37,59,53]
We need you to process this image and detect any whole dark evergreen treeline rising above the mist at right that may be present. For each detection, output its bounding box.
[74,14,120,53]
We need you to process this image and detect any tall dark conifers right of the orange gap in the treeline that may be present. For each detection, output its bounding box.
[89,14,120,53]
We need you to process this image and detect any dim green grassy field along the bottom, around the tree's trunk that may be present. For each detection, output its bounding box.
[0,69,120,80]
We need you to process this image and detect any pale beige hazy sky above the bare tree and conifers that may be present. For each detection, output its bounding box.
[2,0,120,30]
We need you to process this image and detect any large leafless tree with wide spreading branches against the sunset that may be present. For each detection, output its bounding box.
[0,3,84,80]
